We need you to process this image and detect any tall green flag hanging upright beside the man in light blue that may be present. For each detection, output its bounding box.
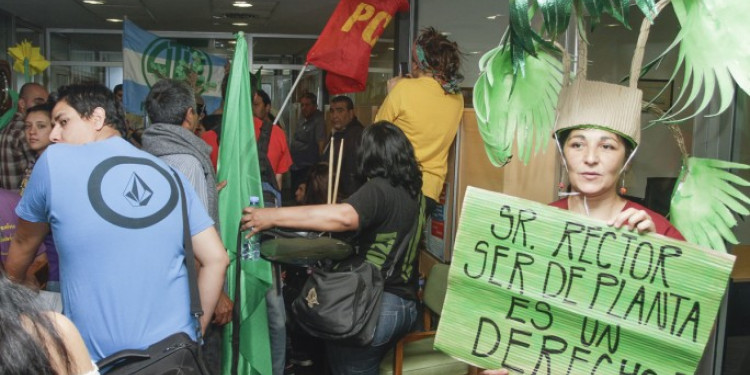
[218,32,272,374]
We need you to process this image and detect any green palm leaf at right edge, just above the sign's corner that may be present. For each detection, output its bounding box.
[669,157,750,251]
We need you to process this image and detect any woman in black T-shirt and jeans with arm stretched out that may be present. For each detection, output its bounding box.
[242,122,422,374]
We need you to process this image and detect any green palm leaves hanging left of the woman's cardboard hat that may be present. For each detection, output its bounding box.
[474,46,563,167]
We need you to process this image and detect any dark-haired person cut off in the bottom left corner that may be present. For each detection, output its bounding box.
[0,268,99,375]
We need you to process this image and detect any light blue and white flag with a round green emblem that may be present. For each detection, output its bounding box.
[122,20,227,115]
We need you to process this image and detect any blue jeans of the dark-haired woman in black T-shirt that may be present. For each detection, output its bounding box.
[326,292,417,375]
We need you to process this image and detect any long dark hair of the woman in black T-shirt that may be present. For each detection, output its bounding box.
[357,121,422,197]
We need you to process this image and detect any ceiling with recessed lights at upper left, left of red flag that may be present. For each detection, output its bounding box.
[0,0,346,34]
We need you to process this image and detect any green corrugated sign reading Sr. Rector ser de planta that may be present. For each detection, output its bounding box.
[435,187,734,375]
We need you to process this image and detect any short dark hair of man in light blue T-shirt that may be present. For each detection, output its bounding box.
[54,83,125,135]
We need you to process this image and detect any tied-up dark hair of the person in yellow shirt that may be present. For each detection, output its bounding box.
[415,27,463,90]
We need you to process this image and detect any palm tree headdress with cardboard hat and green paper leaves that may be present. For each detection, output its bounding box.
[473,0,750,254]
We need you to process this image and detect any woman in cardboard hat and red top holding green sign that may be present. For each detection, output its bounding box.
[482,79,685,375]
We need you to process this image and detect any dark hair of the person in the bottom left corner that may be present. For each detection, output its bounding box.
[0,268,73,375]
